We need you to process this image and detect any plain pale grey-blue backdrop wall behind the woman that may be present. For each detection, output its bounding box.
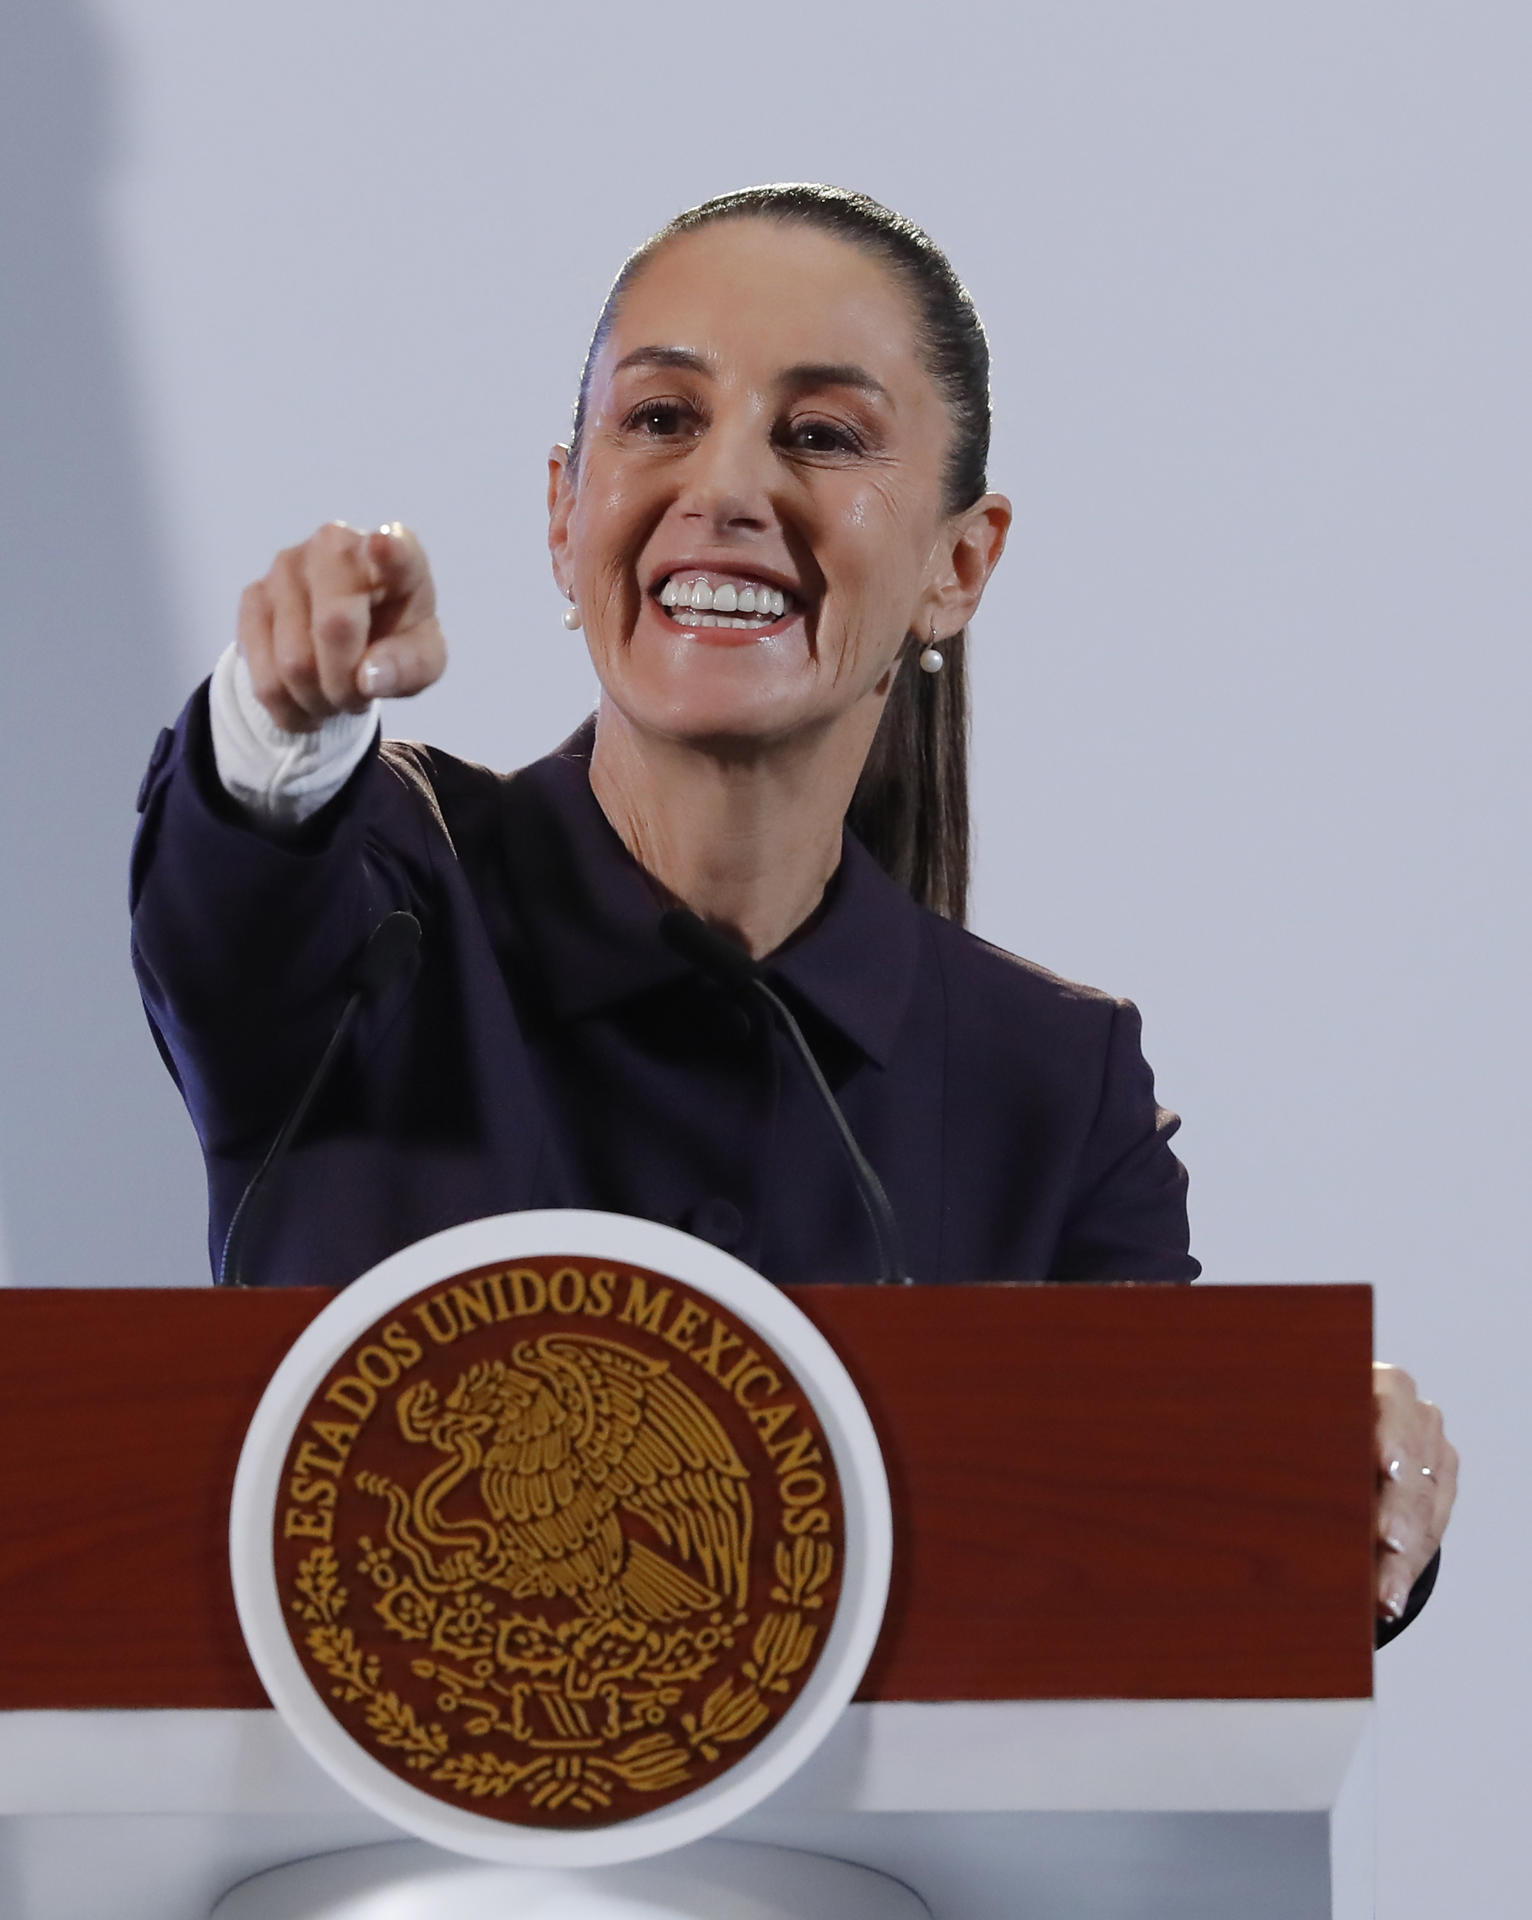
[0,0,1532,1920]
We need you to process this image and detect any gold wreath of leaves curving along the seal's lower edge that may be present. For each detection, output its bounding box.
[292,1534,835,1812]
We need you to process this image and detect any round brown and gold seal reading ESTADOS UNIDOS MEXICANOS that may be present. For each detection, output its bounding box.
[273,1256,845,1828]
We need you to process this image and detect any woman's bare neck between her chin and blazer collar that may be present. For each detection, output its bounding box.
[591,699,877,958]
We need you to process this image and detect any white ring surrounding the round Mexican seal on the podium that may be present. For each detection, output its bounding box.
[228,1210,893,1866]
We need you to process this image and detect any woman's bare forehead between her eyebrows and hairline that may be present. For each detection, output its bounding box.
[595,219,935,403]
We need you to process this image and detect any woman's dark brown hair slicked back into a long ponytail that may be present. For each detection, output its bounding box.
[572,184,989,924]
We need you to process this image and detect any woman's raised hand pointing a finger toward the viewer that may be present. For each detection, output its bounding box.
[240,520,447,733]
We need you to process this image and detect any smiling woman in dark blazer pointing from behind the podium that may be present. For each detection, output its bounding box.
[125,186,1455,1620]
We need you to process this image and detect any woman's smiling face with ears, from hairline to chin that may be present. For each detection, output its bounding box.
[549,217,1008,749]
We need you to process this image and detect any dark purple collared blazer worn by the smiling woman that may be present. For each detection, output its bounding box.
[132,689,1198,1286]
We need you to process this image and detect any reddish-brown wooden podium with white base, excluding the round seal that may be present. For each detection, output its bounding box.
[0,1284,1375,1920]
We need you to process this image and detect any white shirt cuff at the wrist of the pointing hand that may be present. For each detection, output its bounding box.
[207,645,378,826]
